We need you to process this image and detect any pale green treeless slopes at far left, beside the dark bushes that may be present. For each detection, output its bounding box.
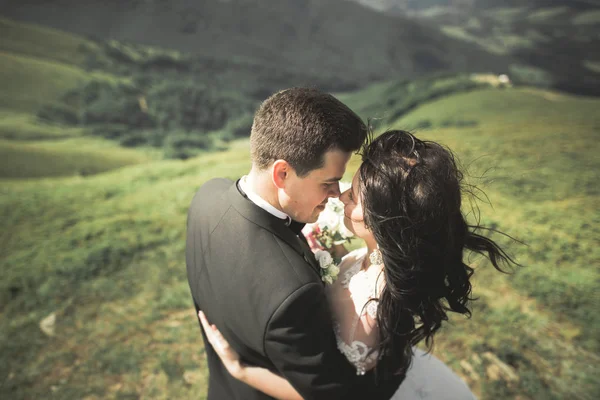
[0,18,160,179]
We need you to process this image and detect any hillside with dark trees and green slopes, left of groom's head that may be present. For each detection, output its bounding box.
[0,18,382,167]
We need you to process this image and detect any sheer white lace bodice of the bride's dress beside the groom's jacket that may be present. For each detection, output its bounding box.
[327,248,384,375]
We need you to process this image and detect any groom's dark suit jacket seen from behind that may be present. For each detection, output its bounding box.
[186,179,401,400]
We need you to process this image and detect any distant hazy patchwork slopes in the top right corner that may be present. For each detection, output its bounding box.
[358,0,600,95]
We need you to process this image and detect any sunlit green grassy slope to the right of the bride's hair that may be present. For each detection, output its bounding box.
[397,90,600,399]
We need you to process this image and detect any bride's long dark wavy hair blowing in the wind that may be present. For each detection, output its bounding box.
[359,130,514,376]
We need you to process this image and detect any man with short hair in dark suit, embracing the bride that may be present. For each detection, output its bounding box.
[186,88,401,400]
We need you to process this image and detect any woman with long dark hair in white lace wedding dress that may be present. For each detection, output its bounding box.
[199,130,513,399]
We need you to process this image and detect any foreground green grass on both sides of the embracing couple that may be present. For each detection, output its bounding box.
[0,83,600,399]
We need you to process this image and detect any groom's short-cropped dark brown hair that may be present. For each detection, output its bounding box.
[250,88,367,176]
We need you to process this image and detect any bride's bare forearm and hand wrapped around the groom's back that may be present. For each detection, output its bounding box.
[198,311,302,400]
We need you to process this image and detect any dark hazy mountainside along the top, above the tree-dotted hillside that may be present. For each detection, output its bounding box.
[0,0,507,85]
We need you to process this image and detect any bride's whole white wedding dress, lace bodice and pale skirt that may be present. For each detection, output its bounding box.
[327,248,475,400]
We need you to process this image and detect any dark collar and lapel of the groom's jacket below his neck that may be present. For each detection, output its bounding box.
[228,182,319,274]
